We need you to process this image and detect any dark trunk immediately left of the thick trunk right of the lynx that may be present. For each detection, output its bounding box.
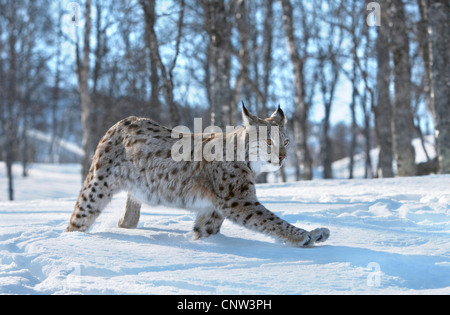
[373,8,394,177]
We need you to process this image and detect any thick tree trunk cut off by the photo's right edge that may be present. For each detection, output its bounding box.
[428,0,450,174]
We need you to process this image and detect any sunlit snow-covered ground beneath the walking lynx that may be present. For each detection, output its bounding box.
[0,163,450,294]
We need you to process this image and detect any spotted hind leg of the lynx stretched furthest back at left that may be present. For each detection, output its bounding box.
[66,169,118,232]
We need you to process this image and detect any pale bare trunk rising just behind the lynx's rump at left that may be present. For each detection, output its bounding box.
[77,0,94,180]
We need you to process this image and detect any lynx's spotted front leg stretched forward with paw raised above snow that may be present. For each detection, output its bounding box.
[222,200,330,247]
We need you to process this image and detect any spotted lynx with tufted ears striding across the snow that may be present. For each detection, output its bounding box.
[66,104,330,247]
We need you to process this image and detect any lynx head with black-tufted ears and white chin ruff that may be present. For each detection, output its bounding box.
[242,103,289,172]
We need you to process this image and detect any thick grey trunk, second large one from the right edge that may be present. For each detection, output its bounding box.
[388,0,416,176]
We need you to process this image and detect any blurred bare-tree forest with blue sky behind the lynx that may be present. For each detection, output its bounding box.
[0,0,450,200]
